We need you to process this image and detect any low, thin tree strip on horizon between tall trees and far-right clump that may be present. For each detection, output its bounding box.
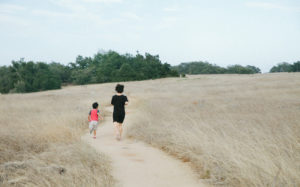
[173,61,261,74]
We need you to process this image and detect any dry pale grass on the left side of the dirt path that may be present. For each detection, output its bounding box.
[0,85,114,186]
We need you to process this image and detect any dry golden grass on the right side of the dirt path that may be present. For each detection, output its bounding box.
[127,73,300,186]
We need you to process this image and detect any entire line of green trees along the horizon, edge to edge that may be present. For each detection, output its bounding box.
[0,51,300,93]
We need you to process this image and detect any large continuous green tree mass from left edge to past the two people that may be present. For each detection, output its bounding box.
[0,51,178,93]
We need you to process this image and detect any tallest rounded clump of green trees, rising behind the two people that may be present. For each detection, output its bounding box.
[69,51,178,84]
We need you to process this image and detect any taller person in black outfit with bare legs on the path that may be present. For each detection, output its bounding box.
[111,84,128,140]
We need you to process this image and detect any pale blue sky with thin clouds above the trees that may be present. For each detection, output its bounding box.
[0,0,300,72]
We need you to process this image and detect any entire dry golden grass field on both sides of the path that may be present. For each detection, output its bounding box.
[0,73,300,186]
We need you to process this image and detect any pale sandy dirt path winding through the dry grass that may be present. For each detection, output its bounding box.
[82,104,204,187]
